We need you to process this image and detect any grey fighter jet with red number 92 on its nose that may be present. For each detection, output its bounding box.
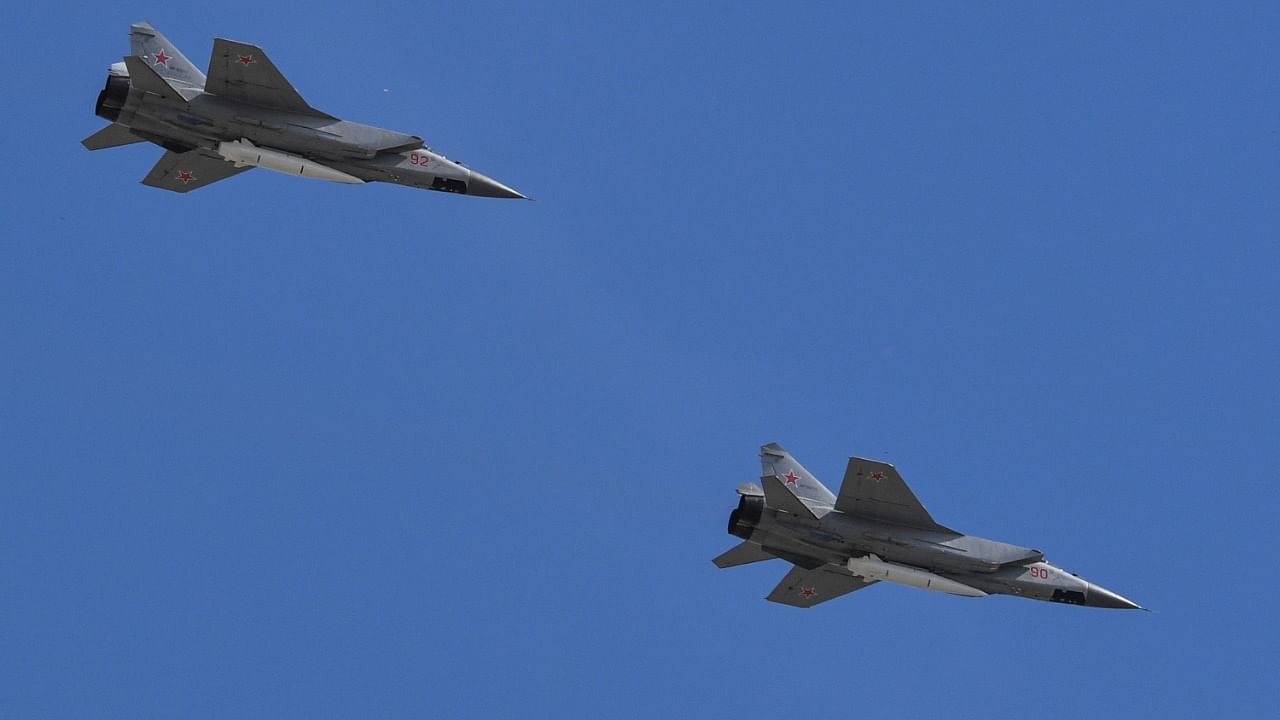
[83,23,525,197]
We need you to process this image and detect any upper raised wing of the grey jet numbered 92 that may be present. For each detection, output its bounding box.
[205,37,330,118]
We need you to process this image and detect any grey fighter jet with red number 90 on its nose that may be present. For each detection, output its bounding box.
[714,443,1144,610]
